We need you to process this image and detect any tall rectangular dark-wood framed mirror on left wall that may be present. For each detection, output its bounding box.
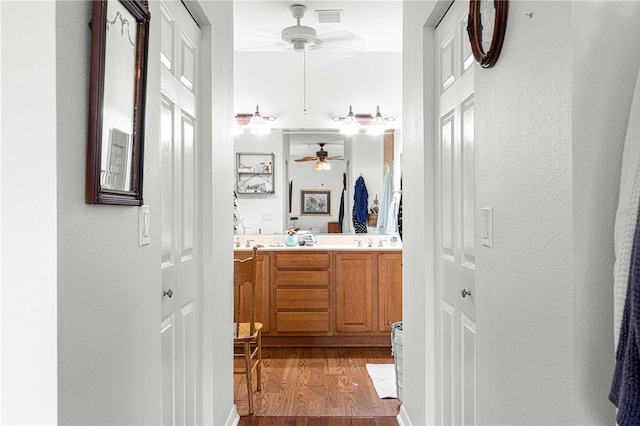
[85,0,150,206]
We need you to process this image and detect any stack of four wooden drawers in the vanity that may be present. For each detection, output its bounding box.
[273,252,331,336]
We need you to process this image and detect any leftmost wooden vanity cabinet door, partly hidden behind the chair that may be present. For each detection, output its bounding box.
[235,251,271,334]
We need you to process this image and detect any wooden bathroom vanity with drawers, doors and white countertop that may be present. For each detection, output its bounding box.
[235,236,402,346]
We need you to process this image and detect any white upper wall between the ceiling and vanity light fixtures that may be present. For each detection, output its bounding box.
[234,50,402,129]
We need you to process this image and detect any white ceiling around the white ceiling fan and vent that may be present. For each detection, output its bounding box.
[233,0,402,52]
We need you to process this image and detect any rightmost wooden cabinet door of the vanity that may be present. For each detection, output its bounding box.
[378,253,402,331]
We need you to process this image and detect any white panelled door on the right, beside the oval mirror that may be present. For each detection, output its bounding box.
[434,1,476,425]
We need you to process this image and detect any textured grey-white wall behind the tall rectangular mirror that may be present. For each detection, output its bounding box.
[56,2,160,424]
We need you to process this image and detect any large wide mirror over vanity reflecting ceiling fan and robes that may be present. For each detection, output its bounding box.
[235,128,402,235]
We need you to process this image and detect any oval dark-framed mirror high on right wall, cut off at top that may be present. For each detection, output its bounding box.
[467,0,509,68]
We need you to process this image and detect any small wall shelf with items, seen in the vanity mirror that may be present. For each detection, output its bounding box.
[236,152,275,195]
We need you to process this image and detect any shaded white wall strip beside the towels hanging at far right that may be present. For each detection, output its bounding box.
[572,2,640,424]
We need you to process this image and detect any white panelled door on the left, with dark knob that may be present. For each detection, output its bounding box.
[158,0,201,425]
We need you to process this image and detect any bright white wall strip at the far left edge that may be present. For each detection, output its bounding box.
[0,2,58,424]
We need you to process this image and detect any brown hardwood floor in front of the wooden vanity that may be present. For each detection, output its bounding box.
[234,348,400,420]
